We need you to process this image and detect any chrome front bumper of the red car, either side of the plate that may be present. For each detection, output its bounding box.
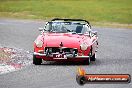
[33,52,89,58]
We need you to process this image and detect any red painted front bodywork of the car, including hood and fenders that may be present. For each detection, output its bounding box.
[34,33,97,61]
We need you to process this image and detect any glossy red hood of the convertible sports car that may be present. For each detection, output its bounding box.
[44,33,89,48]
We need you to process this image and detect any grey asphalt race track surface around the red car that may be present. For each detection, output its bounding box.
[0,19,132,88]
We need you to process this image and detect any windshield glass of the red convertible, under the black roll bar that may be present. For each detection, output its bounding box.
[46,21,90,34]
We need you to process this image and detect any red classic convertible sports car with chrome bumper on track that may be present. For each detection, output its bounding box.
[33,18,98,65]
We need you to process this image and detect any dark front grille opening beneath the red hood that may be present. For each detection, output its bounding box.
[45,47,78,54]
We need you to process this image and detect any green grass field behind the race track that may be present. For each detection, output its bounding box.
[0,0,132,24]
